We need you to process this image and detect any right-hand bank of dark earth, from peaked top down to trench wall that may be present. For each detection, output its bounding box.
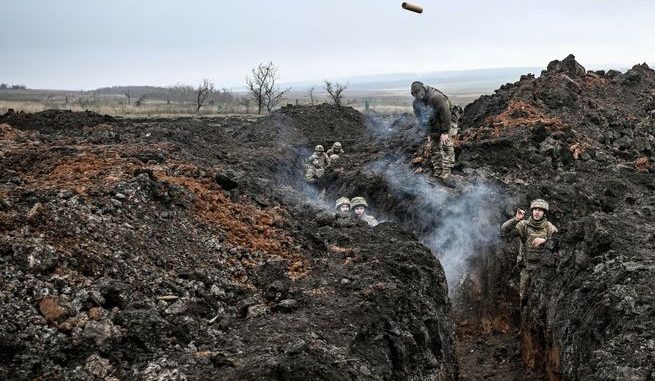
[459,56,655,380]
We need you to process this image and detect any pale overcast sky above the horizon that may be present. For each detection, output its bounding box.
[0,0,655,90]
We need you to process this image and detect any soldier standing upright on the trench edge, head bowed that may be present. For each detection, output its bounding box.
[411,82,461,184]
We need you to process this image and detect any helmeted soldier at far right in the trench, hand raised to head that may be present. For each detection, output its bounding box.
[500,199,557,303]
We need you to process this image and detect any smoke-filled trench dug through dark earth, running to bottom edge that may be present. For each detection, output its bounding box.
[294,114,546,380]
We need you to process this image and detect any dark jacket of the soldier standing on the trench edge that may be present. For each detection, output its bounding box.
[412,86,452,135]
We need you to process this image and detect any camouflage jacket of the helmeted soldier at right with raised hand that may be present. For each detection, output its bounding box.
[500,218,557,262]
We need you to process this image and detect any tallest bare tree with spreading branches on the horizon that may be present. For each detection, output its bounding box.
[246,61,291,114]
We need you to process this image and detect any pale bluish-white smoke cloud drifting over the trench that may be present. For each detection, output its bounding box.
[364,159,502,292]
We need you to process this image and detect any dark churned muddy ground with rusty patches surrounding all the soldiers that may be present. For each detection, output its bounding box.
[0,56,655,380]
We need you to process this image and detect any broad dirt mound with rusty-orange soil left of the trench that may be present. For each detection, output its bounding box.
[0,106,457,380]
